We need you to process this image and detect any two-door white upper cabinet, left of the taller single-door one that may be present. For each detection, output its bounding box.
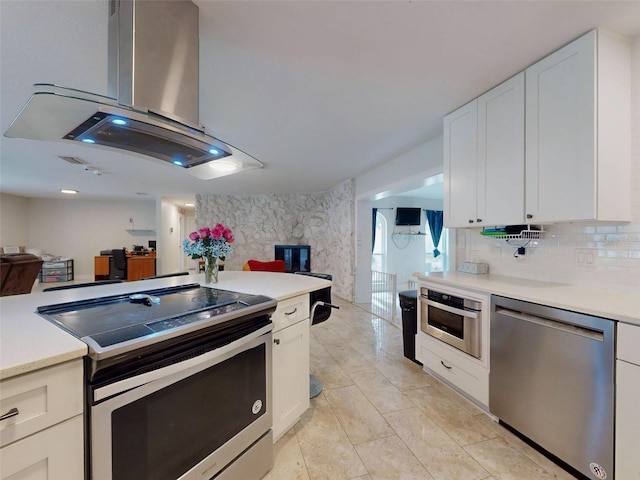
[444,73,524,228]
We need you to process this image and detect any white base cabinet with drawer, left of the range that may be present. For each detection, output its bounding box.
[0,360,84,480]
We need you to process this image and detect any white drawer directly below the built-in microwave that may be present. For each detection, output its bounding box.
[421,341,489,406]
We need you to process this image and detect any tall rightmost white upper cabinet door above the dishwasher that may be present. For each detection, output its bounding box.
[526,32,597,222]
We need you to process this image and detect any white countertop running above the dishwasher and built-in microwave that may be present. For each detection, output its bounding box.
[413,272,640,326]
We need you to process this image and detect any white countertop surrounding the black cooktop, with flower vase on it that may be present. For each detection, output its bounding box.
[0,271,331,380]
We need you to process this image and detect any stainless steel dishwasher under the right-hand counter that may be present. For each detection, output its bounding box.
[489,295,615,479]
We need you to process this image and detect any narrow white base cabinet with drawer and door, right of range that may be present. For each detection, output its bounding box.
[272,294,309,442]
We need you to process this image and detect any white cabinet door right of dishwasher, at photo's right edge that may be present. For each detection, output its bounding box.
[616,360,640,479]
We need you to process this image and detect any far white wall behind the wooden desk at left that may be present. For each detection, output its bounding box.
[17,198,156,281]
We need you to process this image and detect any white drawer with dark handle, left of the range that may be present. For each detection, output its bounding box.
[0,359,83,447]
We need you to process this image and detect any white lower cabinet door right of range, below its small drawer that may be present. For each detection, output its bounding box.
[273,318,309,441]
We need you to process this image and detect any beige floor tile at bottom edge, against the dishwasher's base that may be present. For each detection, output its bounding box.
[465,437,554,480]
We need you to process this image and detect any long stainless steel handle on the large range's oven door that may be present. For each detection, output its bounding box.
[93,323,273,402]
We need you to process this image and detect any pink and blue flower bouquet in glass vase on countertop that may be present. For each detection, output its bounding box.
[182,223,235,283]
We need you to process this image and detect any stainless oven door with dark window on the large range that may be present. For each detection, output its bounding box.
[89,324,273,480]
